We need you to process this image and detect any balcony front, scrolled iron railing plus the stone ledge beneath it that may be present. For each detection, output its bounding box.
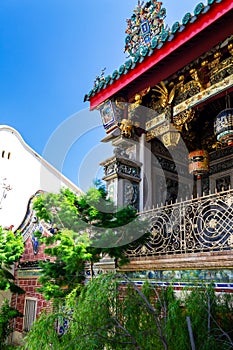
[124,189,233,271]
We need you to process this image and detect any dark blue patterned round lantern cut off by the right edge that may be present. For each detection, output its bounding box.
[214,108,233,146]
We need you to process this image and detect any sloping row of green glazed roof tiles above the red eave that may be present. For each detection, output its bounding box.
[84,0,229,102]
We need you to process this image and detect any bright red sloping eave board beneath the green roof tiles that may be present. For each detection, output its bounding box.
[90,0,233,110]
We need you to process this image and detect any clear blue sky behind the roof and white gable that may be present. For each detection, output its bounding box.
[0,0,203,189]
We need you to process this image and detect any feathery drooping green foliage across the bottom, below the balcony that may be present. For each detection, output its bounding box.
[24,274,233,350]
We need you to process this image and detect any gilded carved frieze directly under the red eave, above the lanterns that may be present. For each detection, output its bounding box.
[145,37,233,130]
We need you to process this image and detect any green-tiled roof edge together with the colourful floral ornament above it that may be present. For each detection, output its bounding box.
[84,0,232,107]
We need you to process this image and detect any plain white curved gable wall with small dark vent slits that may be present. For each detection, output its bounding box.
[0,125,81,230]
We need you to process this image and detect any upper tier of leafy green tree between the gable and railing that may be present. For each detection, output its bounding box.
[34,187,148,257]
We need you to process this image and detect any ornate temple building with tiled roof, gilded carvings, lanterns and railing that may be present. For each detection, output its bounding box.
[85,0,233,292]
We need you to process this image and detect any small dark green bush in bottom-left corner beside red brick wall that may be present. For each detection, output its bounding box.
[0,299,22,349]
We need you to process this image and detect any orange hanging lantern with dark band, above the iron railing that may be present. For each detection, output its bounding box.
[189,150,209,180]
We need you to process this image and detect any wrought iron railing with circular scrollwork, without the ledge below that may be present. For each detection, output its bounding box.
[127,190,233,257]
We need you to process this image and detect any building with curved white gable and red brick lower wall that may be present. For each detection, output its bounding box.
[0,125,81,342]
